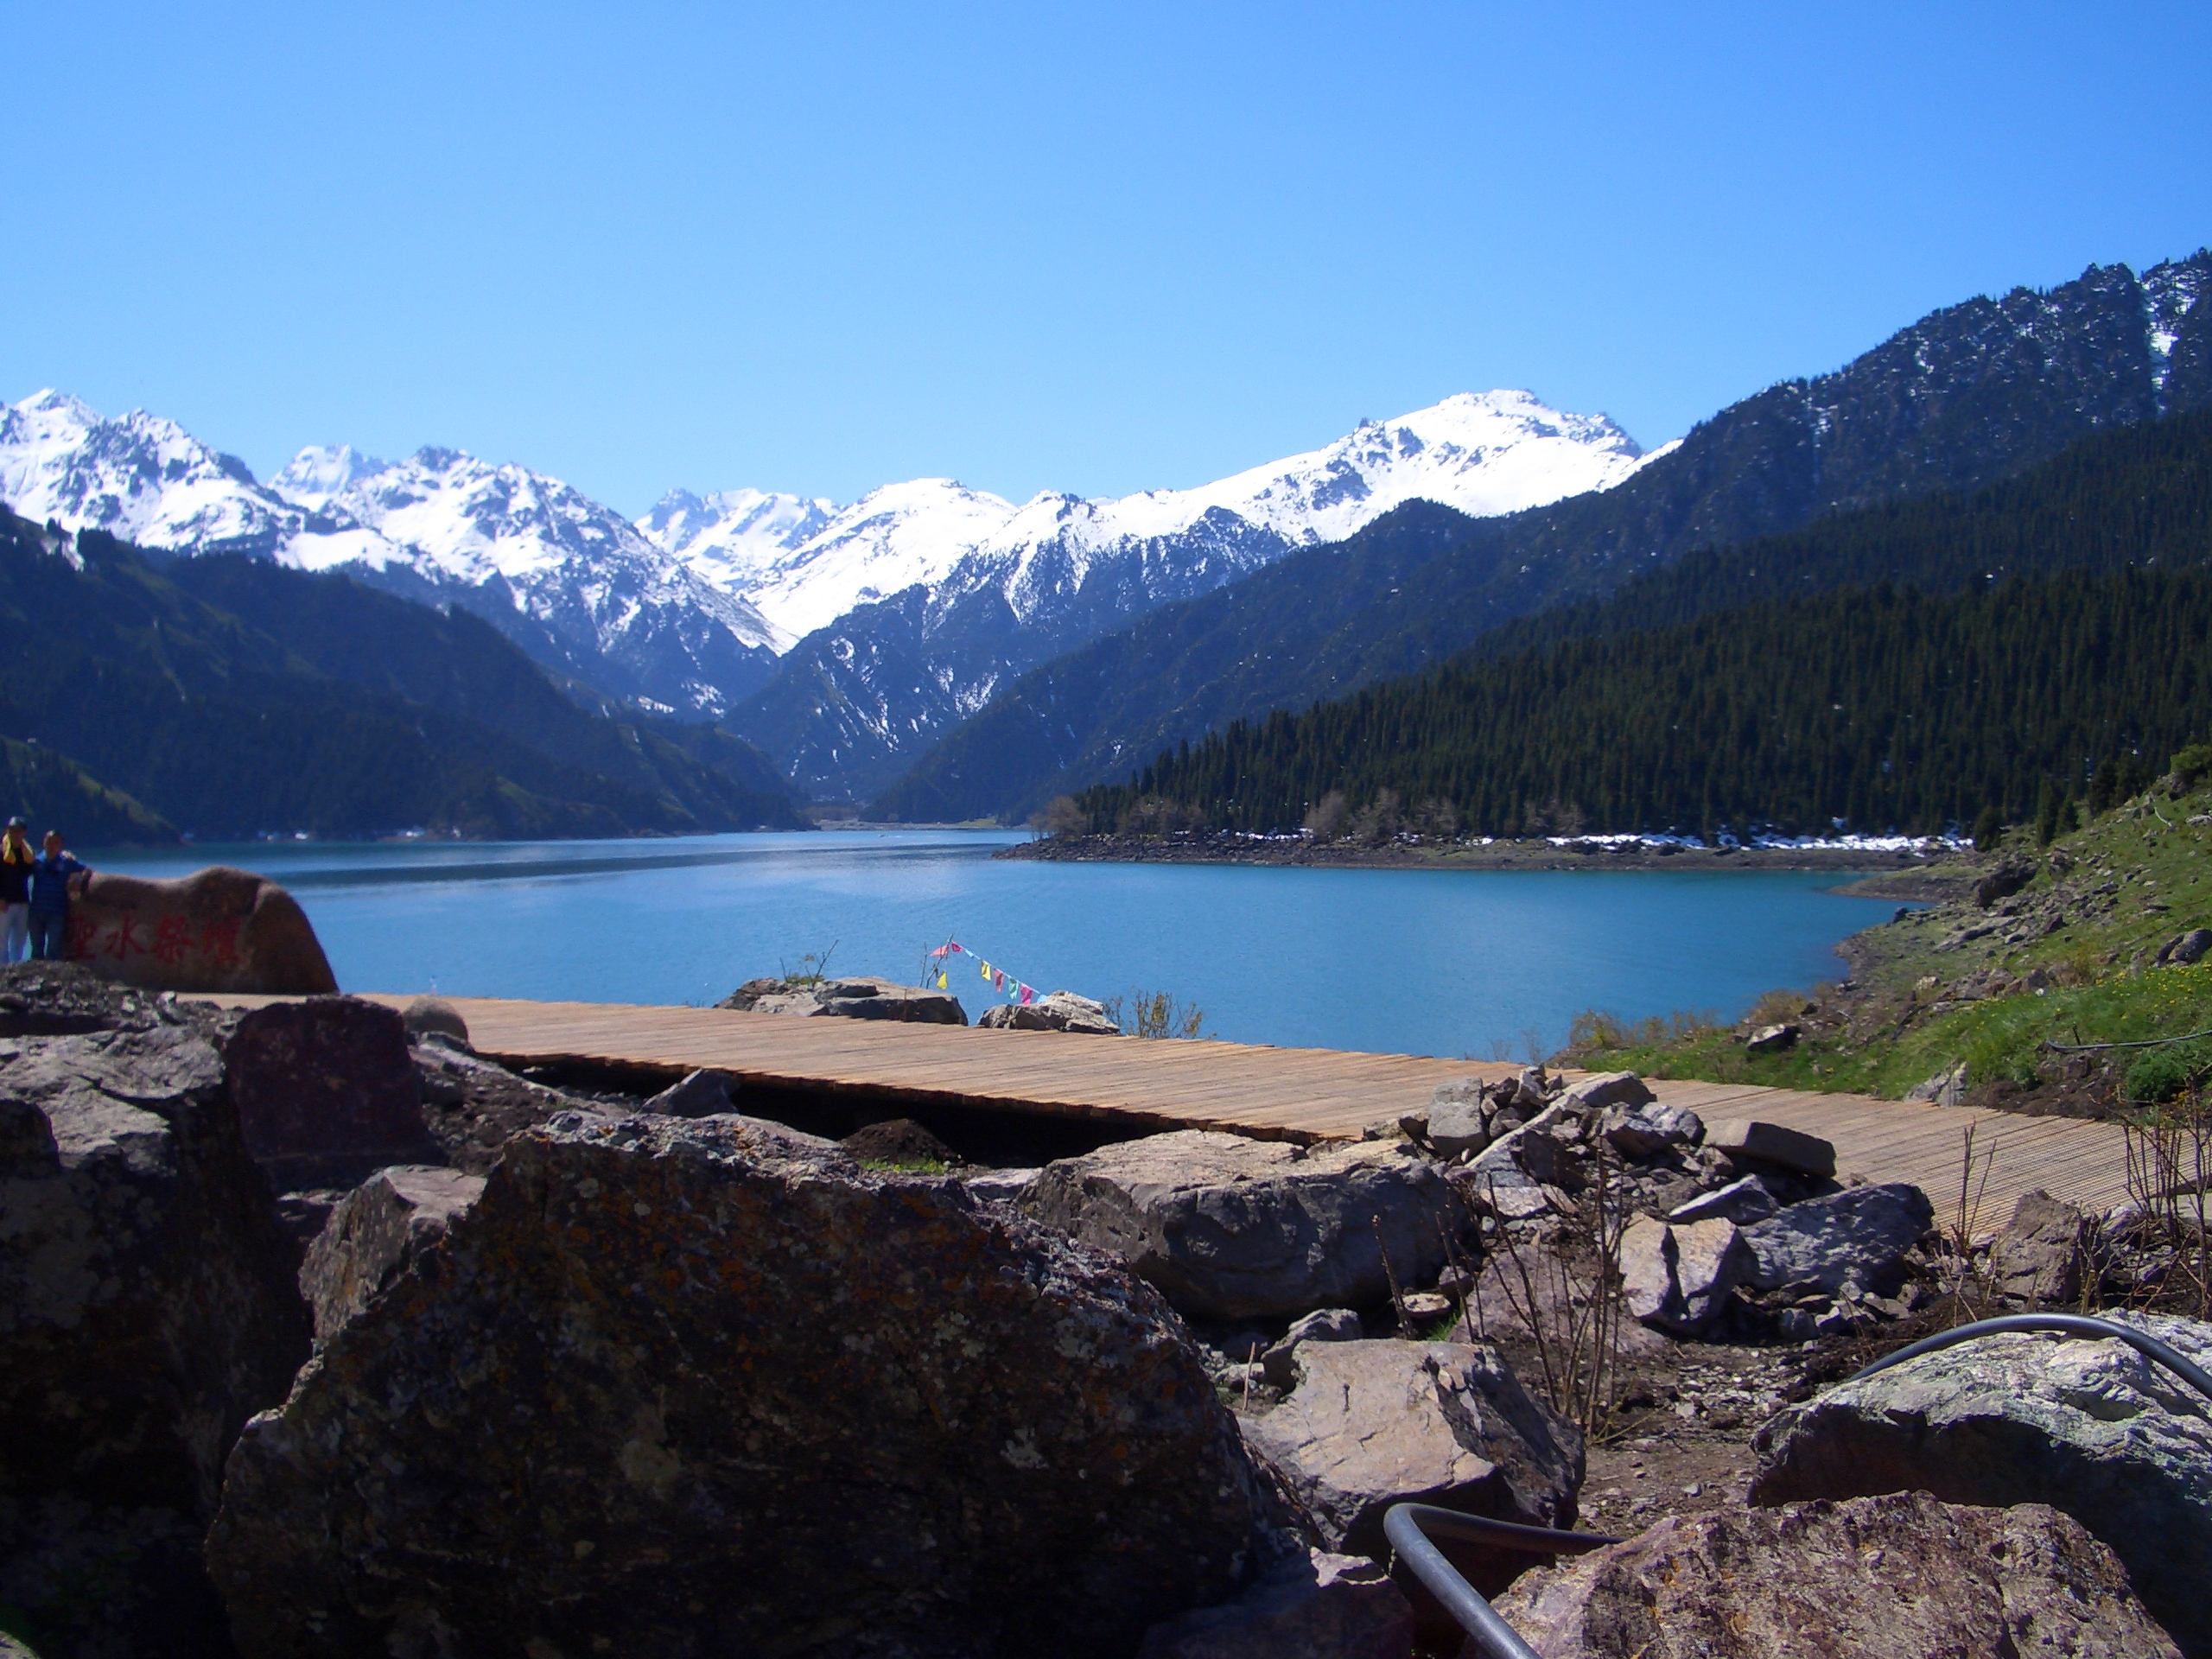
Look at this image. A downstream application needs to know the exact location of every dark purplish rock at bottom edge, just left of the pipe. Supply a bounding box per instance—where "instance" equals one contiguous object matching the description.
[1132,1548,1414,1659]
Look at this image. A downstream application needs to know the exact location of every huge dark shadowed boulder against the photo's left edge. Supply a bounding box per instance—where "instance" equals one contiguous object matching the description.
[0,1024,308,1655]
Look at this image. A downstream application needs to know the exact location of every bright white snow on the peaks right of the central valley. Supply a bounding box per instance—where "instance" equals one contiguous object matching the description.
[639,391,1642,637]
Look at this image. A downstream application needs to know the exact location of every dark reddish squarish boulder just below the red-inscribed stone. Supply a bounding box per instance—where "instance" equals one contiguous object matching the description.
[224,998,445,1192]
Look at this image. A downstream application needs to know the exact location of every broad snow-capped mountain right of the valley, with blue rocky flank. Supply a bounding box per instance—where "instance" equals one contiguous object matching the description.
[668,391,1646,794]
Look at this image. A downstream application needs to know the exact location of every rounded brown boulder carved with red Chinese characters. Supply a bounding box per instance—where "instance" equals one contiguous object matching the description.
[68,865,339,995]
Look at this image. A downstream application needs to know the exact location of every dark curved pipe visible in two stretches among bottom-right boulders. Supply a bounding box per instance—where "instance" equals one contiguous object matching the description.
[1382,1314,2212,1659]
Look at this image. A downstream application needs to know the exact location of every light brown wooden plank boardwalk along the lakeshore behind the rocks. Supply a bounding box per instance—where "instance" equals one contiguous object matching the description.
[285,998,2128,1230]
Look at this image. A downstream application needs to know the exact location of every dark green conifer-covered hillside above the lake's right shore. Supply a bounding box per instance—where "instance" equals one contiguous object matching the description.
[1079,411,2212,834]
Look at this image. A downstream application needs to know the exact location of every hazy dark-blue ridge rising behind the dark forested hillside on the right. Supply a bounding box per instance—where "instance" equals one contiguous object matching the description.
[876,252,2212,818]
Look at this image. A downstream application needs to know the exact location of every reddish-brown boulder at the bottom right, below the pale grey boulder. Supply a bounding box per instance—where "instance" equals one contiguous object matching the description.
[1497,1493,2179,1659]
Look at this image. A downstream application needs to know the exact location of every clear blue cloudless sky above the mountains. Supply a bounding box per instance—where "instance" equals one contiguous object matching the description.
[0,0,2212,513]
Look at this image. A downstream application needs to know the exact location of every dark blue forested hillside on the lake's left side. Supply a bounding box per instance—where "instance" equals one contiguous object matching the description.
[0,515,797,838]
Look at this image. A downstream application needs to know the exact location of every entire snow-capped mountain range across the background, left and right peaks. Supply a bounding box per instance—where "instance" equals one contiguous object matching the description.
[0,391,1642,794]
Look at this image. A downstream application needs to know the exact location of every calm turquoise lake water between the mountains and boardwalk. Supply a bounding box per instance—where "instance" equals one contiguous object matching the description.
[86,832,1891,1059]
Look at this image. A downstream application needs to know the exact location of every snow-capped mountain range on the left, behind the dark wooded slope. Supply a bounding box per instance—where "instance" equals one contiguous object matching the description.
[0,402,791,715]
